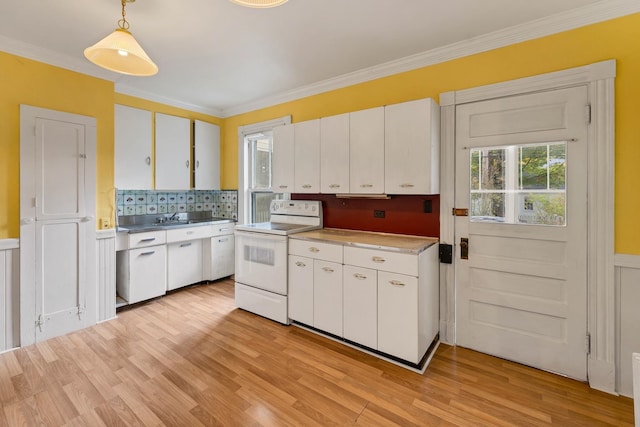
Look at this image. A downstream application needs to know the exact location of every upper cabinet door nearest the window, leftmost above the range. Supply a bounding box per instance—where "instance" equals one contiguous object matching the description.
[271,125,295,193]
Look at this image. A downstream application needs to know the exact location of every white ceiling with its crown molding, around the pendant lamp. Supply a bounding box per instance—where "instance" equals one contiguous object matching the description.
[0,0,637,117]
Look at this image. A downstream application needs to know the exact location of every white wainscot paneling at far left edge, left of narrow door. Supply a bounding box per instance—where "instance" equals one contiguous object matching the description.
[0,239,20,353]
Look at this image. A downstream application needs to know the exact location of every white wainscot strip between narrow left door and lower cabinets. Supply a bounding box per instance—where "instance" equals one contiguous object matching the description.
[96,229,116,322]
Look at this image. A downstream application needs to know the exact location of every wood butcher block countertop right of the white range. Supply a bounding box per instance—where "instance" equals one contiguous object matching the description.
[289,228,438,254]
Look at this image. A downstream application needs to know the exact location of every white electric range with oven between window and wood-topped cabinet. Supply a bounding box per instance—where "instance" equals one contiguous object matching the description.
[235,200,322,324]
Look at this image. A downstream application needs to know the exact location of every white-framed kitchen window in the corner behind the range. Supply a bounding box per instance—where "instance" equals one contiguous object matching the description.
[238,116,291,223]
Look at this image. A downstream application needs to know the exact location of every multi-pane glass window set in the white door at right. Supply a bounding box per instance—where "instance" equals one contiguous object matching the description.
[469,142,567,226]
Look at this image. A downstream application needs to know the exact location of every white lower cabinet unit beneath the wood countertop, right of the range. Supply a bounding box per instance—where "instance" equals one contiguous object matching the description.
[289,233,439,366]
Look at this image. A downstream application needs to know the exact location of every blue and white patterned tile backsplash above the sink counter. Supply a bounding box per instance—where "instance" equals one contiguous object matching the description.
[116,190,238,220]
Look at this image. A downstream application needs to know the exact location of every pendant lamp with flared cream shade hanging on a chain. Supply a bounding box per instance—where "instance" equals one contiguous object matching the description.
[84,0,158,76]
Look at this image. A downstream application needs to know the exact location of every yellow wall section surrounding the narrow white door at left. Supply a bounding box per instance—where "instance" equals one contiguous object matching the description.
[0,52,115,238]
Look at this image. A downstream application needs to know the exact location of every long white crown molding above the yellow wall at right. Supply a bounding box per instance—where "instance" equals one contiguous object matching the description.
[221,0,640,118]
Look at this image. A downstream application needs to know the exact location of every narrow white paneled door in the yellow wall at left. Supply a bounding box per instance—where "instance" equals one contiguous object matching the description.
[20,106,96,345]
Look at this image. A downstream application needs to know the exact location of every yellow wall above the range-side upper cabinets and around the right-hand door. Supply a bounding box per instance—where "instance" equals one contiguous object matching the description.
[223,14,640,254]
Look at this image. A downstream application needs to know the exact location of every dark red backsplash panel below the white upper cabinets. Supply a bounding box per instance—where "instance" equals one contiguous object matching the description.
[291,194,440,237]
